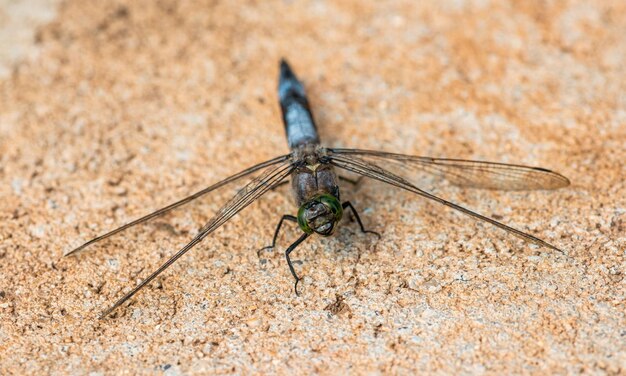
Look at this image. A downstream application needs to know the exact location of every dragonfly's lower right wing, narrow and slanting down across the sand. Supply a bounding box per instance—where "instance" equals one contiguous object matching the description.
[329,154,565,254]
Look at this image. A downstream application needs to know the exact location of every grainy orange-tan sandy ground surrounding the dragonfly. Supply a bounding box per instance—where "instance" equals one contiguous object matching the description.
[0,0,626,375]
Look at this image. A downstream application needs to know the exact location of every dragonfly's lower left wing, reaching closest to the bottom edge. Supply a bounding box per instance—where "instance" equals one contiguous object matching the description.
[100,161,294,318]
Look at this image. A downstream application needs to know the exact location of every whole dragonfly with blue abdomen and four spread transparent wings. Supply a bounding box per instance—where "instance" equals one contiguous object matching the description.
[66,59,570,318]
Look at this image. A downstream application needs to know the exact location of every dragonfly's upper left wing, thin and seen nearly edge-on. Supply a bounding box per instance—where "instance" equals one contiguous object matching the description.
[65,154,290,256]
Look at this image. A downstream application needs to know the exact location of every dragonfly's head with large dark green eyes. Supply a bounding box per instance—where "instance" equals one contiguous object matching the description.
[298,194,343,236]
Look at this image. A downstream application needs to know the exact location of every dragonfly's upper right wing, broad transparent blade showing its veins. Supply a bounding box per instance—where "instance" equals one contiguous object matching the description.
[329,149,570,191]
